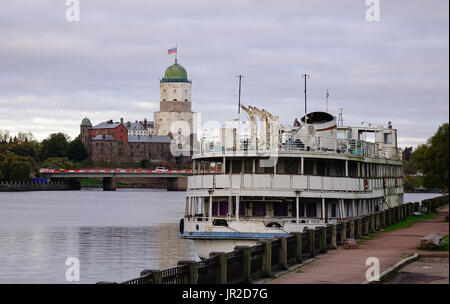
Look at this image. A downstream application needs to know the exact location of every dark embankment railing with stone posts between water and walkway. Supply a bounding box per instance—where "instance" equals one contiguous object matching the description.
[111,195,448,284]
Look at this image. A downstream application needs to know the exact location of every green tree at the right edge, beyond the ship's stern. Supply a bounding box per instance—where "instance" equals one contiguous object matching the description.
[411,123,449,191]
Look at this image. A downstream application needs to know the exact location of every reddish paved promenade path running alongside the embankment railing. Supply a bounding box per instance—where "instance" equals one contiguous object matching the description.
[267,205,449,284]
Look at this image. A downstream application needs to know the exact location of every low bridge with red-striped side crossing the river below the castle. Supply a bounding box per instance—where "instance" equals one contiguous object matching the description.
[40,169,197,191]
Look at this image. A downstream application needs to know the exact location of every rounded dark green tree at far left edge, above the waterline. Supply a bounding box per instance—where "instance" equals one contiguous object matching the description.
[0,153,32,181]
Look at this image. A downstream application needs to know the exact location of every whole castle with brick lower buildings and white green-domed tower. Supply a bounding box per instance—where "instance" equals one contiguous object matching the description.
[80,59,196,167]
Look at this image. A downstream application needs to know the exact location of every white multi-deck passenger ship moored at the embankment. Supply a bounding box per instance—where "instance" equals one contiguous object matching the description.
[180,106,403,257]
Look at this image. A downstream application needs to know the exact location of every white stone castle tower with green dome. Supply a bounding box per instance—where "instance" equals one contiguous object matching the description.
[154,59,194,137]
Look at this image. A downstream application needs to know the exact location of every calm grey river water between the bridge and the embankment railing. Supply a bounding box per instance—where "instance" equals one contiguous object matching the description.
[0,189,439,283]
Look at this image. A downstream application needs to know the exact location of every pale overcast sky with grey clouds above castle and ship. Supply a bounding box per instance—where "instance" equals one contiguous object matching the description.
[0,0,449,147]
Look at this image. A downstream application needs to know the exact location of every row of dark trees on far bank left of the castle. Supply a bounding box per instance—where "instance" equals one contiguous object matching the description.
[0,130,89,181]
